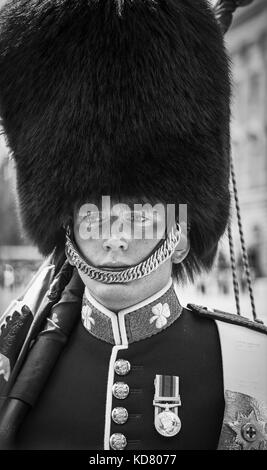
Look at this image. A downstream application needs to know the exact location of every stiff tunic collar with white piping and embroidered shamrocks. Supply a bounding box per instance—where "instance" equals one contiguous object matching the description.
[82,279,183,346]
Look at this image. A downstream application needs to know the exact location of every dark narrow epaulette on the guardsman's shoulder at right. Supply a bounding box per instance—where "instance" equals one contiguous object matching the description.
[187,304,267,334]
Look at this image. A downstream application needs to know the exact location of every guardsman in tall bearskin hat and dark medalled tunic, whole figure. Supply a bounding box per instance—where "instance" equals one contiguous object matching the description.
[0,0,267,450]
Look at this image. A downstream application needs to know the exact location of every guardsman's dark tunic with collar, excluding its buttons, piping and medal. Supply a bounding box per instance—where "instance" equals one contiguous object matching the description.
[16,280,224,450]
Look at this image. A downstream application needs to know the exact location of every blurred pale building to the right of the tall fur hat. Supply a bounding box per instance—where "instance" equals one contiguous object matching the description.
[226,0,267,277]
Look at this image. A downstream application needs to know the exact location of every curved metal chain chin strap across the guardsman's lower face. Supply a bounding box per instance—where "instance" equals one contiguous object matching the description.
[65,223,181,284]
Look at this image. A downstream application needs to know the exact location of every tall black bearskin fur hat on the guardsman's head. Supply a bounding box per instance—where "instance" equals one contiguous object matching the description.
[0,0,230,280]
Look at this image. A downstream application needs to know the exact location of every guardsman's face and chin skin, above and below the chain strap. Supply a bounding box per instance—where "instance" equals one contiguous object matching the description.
[74,202,175,310]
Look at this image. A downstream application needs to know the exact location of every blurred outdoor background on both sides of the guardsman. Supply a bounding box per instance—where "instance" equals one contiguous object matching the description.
[0,0,267,323]
